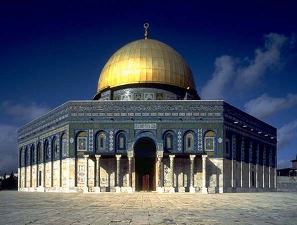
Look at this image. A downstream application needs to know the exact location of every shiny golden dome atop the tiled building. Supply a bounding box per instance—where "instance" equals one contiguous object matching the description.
[97,39,195,92]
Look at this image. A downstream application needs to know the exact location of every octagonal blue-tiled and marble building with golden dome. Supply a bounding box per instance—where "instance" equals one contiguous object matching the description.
[18,31,277,193]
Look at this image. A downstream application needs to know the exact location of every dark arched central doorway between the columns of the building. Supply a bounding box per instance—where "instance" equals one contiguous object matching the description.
[134,138,156,191]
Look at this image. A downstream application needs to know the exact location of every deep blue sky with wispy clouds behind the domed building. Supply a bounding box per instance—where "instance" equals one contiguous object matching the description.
[0,0,297,170]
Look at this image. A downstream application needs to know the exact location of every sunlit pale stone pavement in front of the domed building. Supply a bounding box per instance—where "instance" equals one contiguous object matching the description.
[0,191,297,225]
